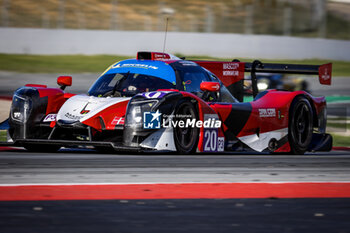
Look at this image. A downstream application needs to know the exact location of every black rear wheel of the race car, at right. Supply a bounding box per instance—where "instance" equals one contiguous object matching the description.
[288,97,313,154]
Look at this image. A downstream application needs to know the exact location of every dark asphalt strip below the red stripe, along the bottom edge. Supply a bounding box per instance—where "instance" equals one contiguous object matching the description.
[0,199,350,233]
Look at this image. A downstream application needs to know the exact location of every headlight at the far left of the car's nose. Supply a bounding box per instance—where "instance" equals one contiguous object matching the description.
[11,95,32,123]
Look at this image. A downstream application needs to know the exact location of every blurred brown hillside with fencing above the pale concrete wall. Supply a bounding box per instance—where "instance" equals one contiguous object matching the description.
[0,0,350,39]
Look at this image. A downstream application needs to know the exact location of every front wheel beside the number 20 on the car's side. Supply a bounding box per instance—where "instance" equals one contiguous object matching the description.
[174,101,199,154]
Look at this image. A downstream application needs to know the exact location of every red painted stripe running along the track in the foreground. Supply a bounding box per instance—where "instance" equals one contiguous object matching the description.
[0,182,350,201]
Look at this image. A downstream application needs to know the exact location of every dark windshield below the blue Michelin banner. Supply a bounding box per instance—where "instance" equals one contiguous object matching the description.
[88,72,176,97]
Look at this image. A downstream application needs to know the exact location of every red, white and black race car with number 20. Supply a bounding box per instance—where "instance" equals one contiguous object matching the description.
[0,52,332,154]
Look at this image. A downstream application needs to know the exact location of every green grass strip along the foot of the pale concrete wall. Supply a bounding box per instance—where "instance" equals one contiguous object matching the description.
[0,54,350,77]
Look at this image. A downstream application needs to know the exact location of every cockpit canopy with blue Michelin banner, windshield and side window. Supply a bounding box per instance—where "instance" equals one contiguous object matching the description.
[88,59,235,102]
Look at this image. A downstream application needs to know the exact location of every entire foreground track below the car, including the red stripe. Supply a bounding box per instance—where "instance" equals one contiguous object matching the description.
[0,150,350,233]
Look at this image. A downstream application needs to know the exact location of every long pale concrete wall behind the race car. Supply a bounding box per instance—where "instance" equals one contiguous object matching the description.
[0,28,350,61]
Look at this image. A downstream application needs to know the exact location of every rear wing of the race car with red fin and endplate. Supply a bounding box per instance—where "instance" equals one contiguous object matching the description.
[194,60,332,101]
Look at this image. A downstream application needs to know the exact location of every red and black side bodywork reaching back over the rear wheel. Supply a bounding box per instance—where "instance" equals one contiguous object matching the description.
[210,90,326,152]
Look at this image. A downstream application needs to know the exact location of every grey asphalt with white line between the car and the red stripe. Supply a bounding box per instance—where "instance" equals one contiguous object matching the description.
[0,149,350,184]
